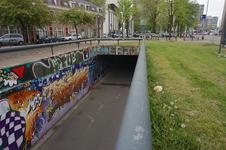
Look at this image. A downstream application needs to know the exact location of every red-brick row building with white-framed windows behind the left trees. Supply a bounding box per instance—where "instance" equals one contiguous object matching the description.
[0,0,103,43]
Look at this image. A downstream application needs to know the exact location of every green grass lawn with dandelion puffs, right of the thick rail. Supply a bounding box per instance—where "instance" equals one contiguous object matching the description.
[118,41,226,150]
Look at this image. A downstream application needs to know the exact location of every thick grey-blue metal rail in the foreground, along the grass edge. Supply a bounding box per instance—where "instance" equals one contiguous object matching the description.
[115,39,152,150]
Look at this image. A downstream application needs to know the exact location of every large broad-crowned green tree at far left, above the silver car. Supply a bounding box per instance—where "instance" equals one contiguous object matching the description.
[0,0,53,43]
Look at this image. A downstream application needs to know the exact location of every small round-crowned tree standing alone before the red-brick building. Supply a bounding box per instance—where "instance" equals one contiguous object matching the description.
[57,6,95,39]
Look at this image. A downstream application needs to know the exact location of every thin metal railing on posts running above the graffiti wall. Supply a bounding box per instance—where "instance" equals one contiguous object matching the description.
[0,38,143,55]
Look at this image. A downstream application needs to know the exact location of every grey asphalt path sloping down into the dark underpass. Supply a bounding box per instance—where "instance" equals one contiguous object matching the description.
[32,56,137,150]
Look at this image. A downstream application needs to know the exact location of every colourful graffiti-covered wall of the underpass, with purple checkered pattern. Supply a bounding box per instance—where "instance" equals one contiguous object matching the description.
[0,46,139,150]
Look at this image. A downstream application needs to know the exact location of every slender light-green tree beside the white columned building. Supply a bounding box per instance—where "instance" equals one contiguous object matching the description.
[116,0,136,37]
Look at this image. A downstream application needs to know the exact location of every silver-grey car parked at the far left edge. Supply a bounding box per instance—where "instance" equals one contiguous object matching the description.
[0,34,24,46]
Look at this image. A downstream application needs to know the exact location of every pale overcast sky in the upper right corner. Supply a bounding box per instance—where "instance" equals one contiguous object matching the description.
[196,0,226,25]
